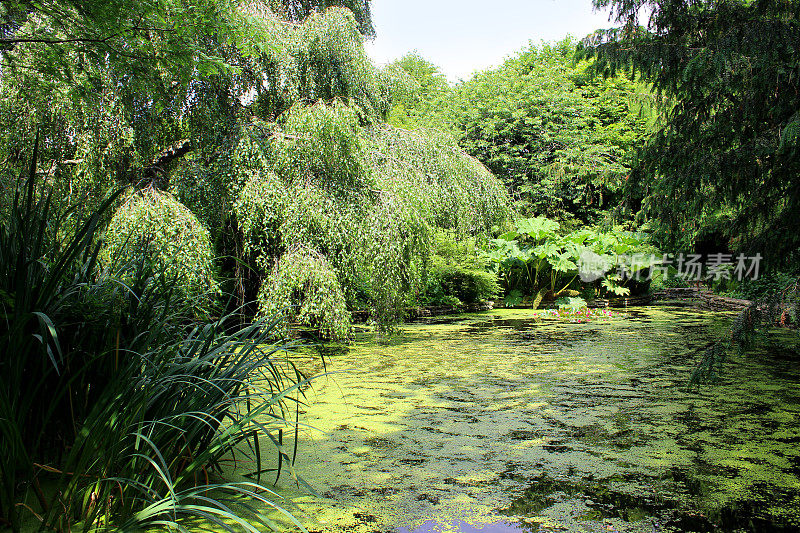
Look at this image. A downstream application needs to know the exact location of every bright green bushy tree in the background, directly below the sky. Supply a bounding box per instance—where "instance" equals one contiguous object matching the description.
[404,39,650,224]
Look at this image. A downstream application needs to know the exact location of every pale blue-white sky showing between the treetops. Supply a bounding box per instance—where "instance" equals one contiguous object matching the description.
[367,0,612,81]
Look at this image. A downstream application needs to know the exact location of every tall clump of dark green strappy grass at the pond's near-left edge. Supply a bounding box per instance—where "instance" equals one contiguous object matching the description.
[0,142,307,531]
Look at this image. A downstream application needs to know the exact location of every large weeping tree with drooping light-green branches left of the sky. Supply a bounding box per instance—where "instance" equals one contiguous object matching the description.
[0,0,508,337]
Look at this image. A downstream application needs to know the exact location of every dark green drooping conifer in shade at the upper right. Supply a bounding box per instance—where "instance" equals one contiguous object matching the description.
[585,0,800,268]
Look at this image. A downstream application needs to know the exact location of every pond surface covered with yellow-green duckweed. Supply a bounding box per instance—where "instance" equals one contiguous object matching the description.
[264,308,800,533]
